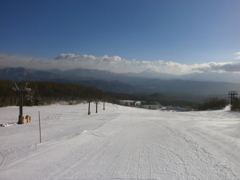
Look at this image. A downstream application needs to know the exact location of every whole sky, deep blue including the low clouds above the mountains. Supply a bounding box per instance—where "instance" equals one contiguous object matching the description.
[0,0,240,74]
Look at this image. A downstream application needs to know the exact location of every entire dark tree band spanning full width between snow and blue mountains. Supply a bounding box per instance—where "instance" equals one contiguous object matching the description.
[0,80,236,110]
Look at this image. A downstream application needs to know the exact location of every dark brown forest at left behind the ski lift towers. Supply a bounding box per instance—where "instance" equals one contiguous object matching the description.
[0,80,113,107]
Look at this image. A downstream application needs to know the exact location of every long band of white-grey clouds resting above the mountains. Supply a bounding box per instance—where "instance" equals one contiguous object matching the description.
[0,52,240,75]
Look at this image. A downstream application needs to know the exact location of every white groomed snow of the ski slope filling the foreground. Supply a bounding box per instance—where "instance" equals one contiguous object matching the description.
[0,103,240,180]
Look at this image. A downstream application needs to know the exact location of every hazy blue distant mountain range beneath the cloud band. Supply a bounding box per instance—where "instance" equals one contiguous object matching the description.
[0,67,240,95]
